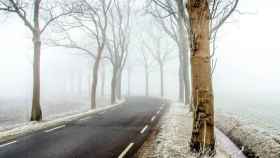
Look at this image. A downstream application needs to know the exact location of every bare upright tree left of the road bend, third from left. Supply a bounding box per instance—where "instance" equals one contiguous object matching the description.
[107,0,132,103]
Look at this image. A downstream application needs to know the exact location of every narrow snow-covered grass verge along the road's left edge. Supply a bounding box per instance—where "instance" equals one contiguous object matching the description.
[0,99,125,142]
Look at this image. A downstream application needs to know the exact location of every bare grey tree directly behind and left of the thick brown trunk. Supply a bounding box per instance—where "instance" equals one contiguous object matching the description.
[147,0,190,105]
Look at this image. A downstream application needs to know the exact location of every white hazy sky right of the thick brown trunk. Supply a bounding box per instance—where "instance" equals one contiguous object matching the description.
[214,0,280,107]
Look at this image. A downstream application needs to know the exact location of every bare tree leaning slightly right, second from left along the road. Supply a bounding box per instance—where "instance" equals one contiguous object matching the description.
[52,0,112,109]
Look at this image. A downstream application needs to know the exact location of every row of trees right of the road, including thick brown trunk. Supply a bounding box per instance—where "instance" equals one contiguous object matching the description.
[147,0,239,154]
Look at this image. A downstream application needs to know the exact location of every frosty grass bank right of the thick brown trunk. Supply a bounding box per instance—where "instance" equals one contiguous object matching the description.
[216,113,280,158]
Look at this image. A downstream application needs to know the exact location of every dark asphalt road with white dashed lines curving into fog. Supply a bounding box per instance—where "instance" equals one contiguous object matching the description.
[0,97,168,158]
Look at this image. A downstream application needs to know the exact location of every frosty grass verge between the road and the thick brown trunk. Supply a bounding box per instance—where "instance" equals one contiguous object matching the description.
[136,103,229,158]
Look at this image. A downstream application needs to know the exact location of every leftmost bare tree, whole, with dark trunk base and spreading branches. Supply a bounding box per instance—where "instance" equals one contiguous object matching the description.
[0,0,72,121]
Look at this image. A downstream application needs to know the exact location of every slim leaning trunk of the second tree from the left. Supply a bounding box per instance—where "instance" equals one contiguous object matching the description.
[91,48,103,109]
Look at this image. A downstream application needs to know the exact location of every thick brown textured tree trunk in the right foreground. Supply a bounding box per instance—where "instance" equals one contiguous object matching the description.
[187,0,215,153]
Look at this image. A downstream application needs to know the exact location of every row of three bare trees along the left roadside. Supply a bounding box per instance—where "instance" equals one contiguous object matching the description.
[0,0,132,121]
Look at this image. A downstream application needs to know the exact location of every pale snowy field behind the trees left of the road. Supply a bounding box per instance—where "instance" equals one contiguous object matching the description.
[0,97,110,131]
